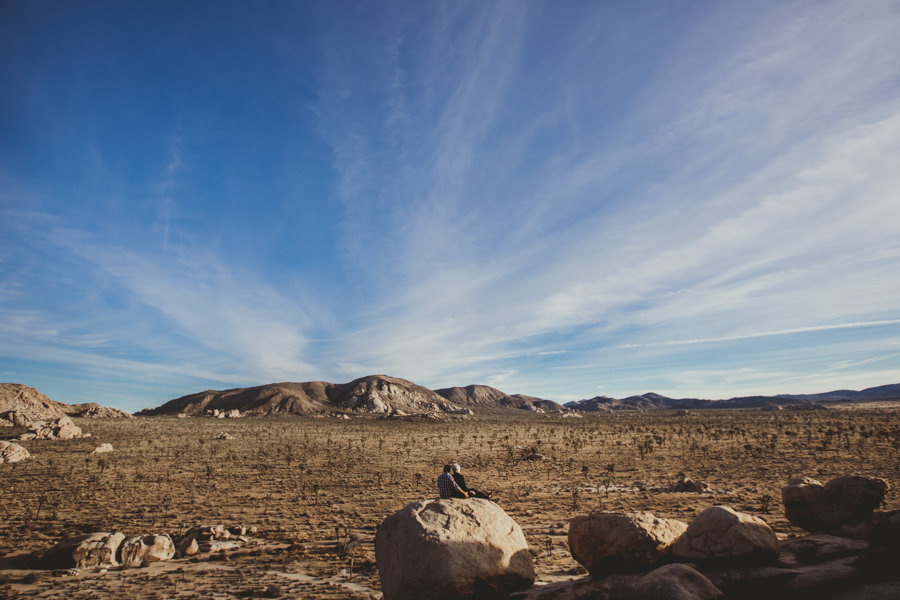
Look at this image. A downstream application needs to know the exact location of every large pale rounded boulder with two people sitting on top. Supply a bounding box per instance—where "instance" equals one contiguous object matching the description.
[375,498,535,600]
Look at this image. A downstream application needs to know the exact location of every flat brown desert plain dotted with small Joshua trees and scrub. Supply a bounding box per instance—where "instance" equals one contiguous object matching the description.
[0,405,900,599]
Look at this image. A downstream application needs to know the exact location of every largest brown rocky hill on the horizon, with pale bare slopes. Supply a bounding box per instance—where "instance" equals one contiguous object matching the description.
[137,375,472,416]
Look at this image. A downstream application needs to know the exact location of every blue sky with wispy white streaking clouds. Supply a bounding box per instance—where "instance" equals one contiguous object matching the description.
[0,0,900,410]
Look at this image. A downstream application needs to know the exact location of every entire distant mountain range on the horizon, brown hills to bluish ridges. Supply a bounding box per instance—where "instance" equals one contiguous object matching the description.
[136,375,900,417]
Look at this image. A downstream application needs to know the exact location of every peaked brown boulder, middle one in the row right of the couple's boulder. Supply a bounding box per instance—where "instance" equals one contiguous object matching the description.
[672,506,779,565]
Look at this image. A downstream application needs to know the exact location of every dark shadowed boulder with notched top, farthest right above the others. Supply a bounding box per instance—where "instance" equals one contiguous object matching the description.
[781,475,888,532]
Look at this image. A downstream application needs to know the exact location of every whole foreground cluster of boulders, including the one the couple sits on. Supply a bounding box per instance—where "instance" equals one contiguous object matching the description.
[375,477,900,600]
